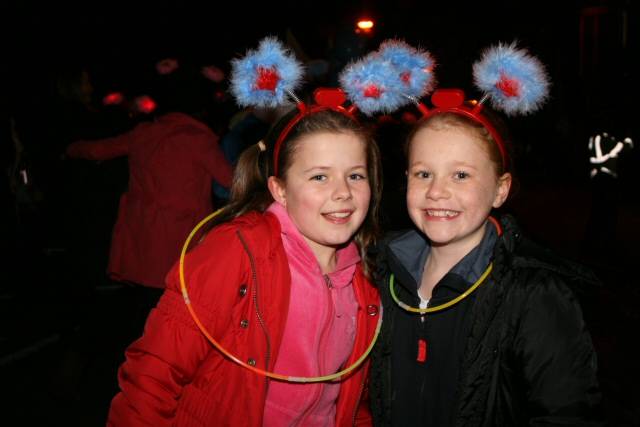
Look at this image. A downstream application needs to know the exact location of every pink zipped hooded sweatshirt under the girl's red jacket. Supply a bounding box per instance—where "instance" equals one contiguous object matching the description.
[263,203,360,427]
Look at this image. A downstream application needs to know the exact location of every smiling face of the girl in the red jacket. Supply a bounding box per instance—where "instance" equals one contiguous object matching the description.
[269,132,371,262]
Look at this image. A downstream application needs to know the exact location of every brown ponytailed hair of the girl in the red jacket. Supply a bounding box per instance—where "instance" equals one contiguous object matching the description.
[213,109,382,276]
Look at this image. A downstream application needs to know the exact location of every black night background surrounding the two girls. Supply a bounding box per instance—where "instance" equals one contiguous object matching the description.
[0,0,640,426]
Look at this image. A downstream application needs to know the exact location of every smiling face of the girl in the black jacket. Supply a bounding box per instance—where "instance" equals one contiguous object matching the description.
[407,126,511,253]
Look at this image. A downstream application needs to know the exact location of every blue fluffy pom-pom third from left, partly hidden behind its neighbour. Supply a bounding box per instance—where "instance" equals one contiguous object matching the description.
[378,40,435,98]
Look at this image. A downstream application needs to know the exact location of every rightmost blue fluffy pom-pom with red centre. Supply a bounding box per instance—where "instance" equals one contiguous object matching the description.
[473,43,549,115]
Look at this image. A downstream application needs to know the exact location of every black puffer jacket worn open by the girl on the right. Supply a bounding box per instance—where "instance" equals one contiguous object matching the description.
[369,217,601,427]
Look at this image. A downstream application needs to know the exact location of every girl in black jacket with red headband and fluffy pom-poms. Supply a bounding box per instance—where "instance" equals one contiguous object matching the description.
[370,42,600,427]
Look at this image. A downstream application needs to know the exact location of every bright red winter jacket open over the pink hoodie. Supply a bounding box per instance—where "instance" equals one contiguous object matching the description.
[108,212,380,427]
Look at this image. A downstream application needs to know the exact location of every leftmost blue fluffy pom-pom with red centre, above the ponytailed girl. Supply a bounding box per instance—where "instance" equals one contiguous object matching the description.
[231,37,302,108]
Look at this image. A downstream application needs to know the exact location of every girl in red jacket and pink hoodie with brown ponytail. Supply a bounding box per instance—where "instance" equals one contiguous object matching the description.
[108,38,381,426]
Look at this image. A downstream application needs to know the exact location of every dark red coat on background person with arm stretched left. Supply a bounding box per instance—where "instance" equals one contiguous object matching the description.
[67,113,232,288]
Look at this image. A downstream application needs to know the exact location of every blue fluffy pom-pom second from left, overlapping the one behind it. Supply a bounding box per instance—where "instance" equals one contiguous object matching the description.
[340,53,410,115]
